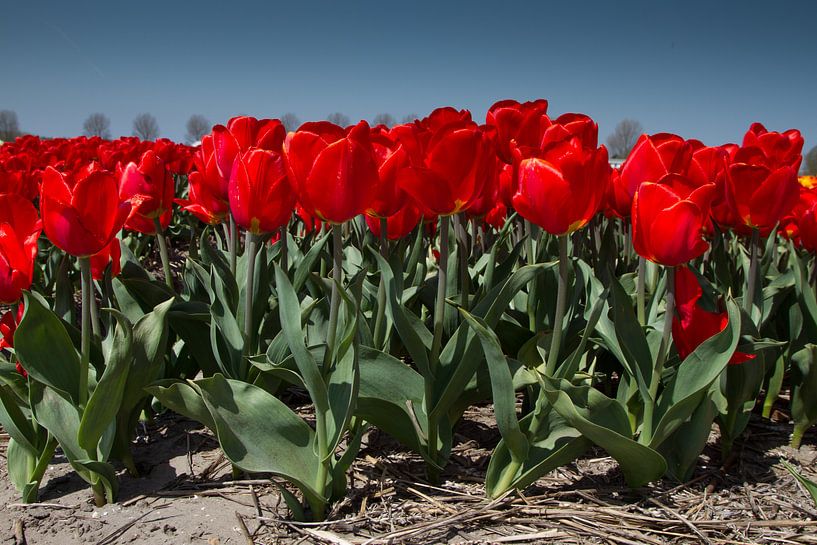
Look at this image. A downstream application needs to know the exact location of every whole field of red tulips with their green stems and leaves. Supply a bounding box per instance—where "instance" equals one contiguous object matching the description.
[0,100,817,536]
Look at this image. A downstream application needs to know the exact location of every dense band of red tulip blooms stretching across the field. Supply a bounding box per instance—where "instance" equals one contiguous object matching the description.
[0,100,817,303]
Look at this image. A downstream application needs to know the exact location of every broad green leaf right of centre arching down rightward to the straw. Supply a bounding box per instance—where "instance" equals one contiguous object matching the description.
[540,377,667,488]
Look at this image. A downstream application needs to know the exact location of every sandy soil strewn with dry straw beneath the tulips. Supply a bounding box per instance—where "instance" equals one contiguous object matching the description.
[0,406,817,545]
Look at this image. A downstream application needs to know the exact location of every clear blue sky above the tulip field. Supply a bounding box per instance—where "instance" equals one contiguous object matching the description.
[0,0,817,149]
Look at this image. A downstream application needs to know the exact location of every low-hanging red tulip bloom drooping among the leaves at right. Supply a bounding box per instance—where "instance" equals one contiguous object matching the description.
[672,267,755,365]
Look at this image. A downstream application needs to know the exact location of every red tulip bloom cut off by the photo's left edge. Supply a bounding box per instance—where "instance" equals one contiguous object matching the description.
[0,193,42,304]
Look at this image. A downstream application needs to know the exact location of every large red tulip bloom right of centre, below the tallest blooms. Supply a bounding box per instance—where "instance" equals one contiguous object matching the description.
[512,116,610,235]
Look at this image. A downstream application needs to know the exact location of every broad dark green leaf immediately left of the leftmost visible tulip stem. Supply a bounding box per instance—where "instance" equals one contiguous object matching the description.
[14,293,85,401]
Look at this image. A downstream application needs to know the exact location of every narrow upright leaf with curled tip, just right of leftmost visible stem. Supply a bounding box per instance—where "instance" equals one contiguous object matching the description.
[77,309,133,452]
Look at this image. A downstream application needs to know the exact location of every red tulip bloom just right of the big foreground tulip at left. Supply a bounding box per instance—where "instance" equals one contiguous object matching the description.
[119,150,176,235]
